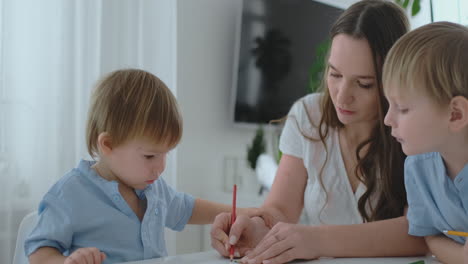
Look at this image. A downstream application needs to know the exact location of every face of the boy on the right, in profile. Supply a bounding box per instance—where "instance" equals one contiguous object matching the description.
[384,87,450,155]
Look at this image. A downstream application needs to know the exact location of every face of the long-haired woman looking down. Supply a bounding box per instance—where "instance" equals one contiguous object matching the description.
[327,34,378,125]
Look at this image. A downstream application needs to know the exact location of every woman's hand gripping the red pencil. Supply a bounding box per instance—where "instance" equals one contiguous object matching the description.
[211,213,270,257]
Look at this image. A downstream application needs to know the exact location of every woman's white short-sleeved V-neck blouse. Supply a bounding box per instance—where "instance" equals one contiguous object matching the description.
[279,93,372,225]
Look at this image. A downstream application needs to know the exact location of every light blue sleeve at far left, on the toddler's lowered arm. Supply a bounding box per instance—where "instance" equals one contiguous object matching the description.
[24,194,73,256]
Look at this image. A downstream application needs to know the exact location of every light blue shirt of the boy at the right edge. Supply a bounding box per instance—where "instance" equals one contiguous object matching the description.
[405,152,468,244]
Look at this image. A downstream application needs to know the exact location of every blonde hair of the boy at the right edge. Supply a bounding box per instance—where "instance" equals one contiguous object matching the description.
[383,22,468,105]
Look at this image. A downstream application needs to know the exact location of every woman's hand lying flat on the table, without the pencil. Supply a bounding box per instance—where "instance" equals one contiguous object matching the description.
[241,222,319,264]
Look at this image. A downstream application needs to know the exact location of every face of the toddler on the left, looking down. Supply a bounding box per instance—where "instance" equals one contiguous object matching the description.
[107,139,170,189]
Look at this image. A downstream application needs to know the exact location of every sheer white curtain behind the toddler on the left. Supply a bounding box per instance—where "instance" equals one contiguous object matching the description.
[0,0,177,263]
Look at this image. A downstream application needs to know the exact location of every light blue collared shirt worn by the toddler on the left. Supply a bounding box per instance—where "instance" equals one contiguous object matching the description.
[24,160,195,263]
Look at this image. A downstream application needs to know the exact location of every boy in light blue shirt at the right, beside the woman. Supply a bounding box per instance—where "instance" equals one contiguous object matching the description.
[383,22,468,263]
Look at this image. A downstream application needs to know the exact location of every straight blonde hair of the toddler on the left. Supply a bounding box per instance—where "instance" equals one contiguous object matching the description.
[86,69,182,157]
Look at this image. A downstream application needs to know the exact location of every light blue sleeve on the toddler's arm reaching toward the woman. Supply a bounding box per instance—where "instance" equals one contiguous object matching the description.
[161,180,195,231]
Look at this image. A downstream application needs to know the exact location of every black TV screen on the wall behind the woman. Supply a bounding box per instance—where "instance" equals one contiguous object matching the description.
[233,0,343,124]
